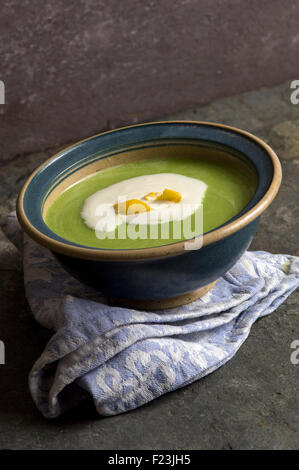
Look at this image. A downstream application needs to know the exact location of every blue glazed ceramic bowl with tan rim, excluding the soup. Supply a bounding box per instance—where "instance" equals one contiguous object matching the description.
[17,121,281,308]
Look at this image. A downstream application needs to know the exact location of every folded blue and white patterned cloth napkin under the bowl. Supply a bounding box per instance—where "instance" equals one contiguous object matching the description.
[2,213,299,418]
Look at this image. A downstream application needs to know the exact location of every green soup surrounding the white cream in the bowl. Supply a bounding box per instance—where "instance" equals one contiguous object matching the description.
[44,155,257,249]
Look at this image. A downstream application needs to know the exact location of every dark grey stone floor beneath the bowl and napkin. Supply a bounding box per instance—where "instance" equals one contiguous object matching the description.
[0,84,299,449]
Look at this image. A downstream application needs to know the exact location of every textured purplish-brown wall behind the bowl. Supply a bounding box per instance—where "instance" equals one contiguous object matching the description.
[0,0,299,160]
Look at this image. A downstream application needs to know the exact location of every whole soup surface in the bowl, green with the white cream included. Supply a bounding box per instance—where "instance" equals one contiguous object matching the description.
[45,157,257,249]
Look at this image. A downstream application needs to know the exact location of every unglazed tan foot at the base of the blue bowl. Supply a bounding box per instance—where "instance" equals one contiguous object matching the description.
[109,280,217,310]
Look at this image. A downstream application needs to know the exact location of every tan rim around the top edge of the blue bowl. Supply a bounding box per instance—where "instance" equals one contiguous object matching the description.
[16,120,282,261]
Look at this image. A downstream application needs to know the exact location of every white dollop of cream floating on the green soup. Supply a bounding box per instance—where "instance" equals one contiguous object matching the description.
[81,173,207,232]
